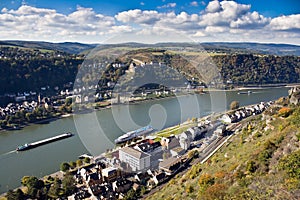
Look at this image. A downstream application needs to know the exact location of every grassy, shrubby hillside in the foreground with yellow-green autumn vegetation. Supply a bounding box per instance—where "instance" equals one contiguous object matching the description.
[147,98,300,200]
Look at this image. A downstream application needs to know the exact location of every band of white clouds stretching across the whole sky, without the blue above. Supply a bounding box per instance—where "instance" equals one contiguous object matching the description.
[0,0,300,44]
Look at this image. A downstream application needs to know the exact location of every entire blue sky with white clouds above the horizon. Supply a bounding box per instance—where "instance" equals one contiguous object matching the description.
[0,0,300,45]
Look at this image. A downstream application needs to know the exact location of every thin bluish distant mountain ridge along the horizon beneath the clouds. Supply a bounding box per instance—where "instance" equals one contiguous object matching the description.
[0,40,300,56]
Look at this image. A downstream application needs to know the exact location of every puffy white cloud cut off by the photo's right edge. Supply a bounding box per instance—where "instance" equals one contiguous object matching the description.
[270,14,300,30]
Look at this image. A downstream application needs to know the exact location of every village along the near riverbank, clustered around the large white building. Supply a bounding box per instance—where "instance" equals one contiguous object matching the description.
[63,101,273,199]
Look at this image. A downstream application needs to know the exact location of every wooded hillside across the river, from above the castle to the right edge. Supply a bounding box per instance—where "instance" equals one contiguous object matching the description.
[121,47,300,87]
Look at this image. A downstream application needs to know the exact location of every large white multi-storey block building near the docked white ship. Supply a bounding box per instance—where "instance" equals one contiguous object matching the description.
[119,147,151,171]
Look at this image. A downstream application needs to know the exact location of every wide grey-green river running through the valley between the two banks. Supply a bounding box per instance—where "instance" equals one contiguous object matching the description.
[0,87,289,194]
